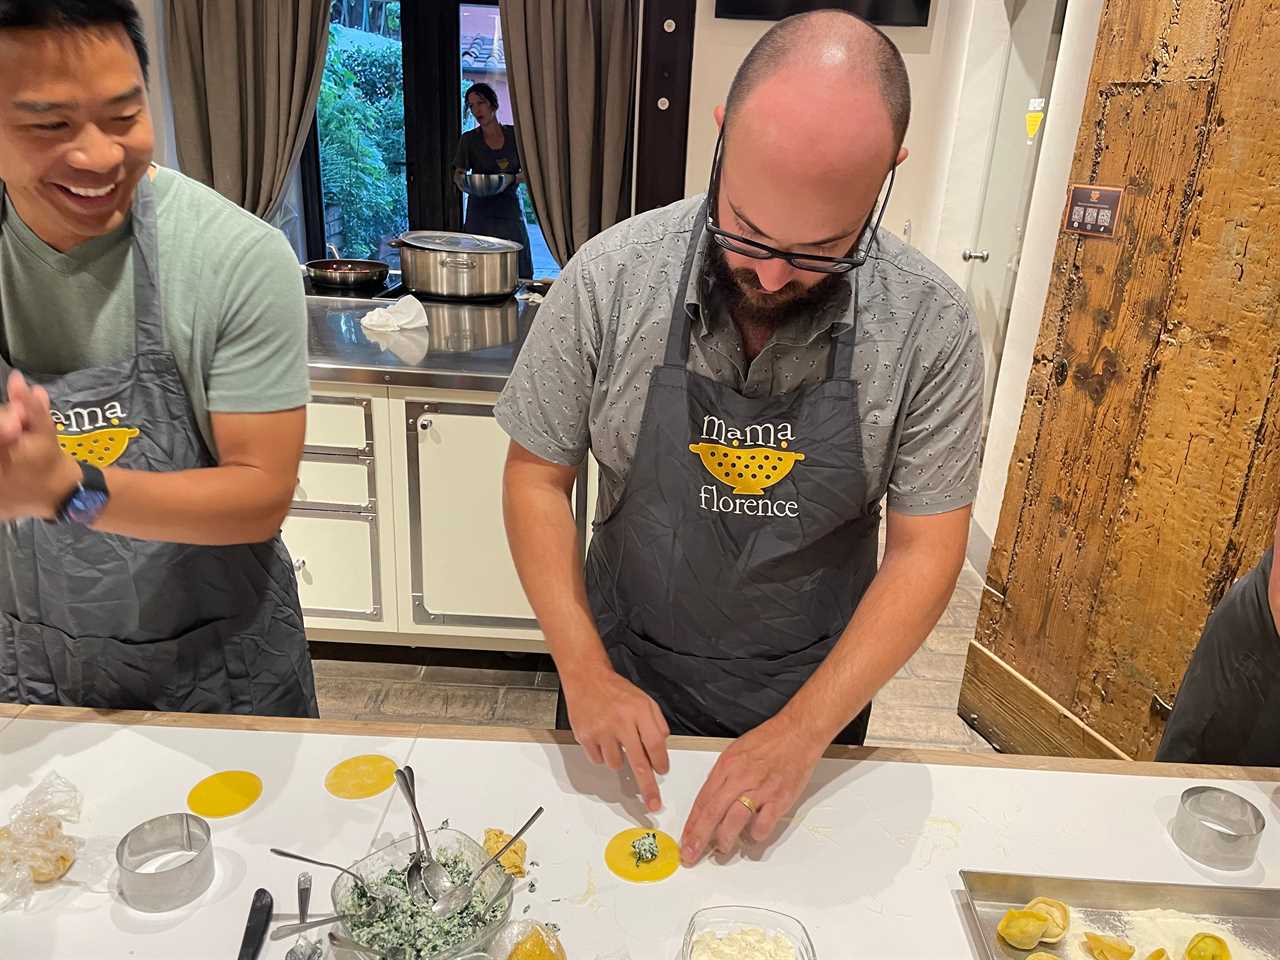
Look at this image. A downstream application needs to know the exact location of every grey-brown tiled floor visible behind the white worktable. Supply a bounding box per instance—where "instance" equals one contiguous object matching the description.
[312,564,991,753]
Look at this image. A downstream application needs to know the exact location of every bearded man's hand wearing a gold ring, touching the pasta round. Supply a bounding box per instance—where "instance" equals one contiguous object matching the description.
[680,713,827,867]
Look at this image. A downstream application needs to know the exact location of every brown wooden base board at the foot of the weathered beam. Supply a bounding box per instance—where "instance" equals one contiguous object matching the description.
[959,644,1129,760]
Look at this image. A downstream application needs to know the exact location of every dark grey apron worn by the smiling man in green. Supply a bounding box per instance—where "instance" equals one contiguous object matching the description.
[0,177,317,717]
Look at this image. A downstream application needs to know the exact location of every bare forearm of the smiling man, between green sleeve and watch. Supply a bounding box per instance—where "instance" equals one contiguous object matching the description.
[93,466,293,545]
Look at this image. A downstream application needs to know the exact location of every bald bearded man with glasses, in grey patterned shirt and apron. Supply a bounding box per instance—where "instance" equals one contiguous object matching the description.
[497,10,983,864]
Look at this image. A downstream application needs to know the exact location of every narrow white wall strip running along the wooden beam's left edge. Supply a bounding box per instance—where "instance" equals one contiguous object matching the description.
[969,0,1103,571]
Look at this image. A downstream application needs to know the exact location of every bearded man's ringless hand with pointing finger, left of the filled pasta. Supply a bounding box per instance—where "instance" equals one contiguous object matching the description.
[561,667,671,810]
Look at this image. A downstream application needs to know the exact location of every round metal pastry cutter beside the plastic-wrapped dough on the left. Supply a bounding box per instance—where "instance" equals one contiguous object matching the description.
[115,813,214,913]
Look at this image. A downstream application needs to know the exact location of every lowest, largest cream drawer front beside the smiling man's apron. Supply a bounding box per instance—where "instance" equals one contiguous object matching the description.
[282,509,383,621]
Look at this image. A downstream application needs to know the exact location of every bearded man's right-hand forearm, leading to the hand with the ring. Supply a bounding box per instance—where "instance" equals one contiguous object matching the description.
[782,527,964,748]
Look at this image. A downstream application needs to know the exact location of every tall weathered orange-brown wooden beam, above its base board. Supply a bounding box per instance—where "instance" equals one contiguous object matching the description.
[977,0,1280,758]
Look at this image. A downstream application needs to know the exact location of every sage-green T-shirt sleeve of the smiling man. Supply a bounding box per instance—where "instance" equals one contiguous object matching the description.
[206,230,311,413]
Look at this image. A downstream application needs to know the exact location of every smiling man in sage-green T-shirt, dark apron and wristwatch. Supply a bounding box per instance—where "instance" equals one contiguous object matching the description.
[0,0,316,716]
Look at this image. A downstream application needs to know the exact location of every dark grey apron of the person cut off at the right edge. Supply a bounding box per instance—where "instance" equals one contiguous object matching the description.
[1156,550,1280,767]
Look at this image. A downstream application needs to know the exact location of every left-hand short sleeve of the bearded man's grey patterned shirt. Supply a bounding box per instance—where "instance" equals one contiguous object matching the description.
[494,253,602,466]
